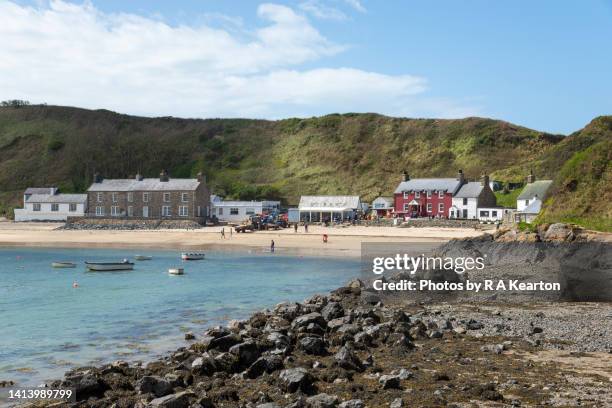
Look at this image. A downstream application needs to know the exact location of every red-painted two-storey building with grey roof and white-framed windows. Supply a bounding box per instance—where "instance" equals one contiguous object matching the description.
[394,170,466,218]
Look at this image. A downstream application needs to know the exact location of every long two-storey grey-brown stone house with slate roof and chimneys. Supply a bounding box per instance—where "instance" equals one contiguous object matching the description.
[87,171,211,222]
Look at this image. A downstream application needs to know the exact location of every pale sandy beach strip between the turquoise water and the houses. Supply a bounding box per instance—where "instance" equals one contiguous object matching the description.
[0,222,483,256]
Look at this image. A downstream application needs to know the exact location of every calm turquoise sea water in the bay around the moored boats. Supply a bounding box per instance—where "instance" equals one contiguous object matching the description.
[0,245,359,385]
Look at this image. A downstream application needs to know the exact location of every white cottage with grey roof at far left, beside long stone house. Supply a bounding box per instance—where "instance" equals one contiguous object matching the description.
[15,187,87,222]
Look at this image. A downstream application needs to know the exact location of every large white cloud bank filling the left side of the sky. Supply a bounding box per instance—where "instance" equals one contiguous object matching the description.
[0,0,477,118]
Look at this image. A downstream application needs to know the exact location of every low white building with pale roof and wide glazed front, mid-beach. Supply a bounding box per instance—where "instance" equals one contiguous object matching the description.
[298,196,362,222]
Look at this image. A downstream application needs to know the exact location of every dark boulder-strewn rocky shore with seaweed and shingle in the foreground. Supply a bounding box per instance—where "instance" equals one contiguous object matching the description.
[9,227,612,408]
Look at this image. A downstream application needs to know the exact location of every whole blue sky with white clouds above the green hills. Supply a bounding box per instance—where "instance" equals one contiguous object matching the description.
[0,0,612,134]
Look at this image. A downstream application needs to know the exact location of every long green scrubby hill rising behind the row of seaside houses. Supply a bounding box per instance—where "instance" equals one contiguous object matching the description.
[0,106,600,231]
